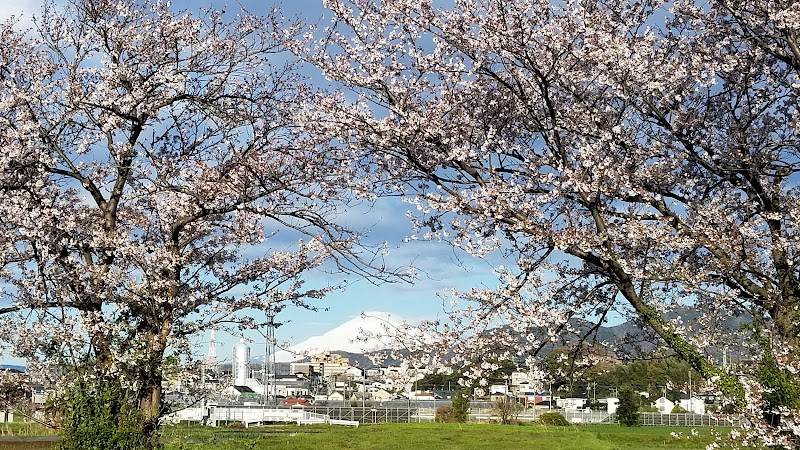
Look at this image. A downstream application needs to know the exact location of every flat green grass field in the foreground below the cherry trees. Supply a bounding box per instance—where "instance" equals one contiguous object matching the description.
[164,424,732,450]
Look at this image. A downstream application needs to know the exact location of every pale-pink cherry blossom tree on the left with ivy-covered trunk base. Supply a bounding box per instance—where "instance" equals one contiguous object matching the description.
[0,0,392,442]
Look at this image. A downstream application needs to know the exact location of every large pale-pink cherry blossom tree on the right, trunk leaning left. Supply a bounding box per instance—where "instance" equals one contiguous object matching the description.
[298,0,800,448]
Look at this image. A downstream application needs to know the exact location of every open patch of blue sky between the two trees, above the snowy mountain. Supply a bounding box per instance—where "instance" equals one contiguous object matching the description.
[245,193,496,356]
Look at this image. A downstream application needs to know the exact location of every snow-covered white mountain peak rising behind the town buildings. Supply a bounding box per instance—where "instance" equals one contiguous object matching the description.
[270,312,403,362]
